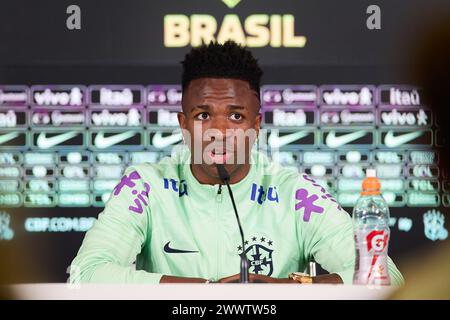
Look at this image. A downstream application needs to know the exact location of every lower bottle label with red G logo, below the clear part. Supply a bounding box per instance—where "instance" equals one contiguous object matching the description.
[354,230,390,285]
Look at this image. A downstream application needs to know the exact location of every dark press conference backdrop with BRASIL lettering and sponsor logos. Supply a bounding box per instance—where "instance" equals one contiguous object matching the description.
[0,0,450,282]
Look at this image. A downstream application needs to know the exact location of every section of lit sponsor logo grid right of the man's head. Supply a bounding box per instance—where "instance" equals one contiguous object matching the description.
[261,85,449,207]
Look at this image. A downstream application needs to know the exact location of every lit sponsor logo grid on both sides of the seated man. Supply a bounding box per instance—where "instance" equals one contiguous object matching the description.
[0,84,450,241]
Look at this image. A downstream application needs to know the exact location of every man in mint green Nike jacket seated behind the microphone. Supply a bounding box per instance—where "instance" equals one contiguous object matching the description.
[71,42,403,285]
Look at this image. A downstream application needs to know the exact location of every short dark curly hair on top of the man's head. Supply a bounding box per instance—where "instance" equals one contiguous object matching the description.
[181,41,263,98]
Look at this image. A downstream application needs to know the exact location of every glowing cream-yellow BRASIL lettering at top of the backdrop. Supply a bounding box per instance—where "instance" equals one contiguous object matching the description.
[164,0,306,48]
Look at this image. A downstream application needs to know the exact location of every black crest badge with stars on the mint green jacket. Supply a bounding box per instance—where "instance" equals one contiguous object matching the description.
[238,236,274,276]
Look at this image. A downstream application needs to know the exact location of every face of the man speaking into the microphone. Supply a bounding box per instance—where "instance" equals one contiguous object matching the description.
[178,78,261,183]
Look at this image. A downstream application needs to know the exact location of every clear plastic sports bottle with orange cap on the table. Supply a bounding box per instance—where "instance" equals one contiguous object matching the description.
[353,169,391,285]
